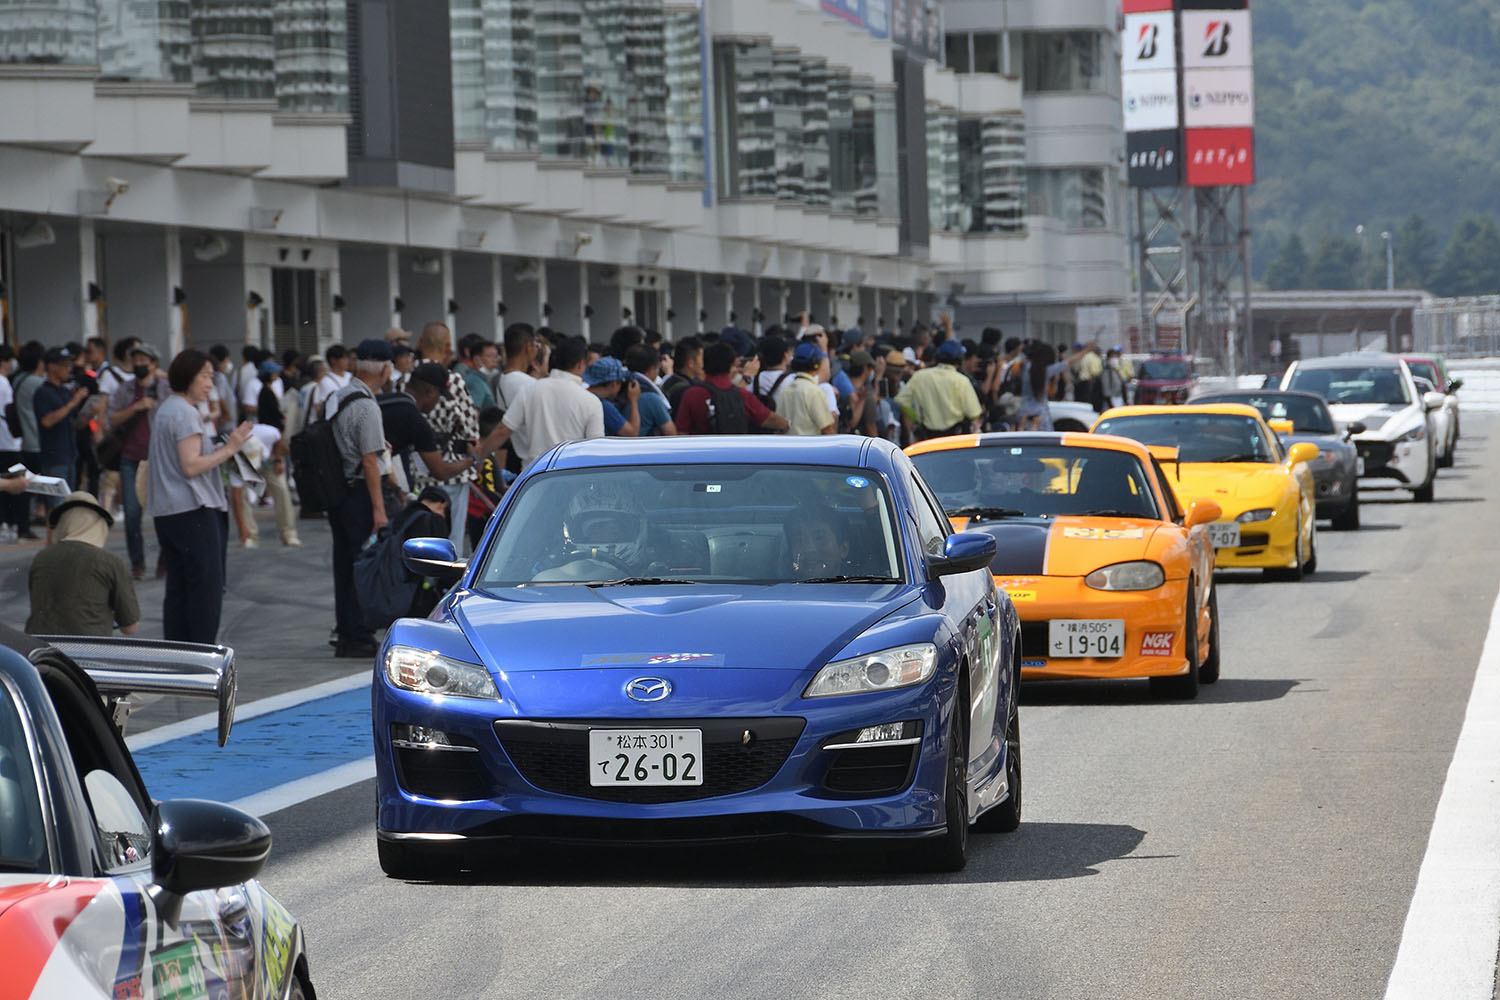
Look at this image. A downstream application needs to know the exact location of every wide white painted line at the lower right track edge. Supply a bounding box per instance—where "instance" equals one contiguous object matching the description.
[1386,590,1500,1000]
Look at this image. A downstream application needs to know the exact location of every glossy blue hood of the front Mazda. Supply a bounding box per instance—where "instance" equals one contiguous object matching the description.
[447,583,918,675]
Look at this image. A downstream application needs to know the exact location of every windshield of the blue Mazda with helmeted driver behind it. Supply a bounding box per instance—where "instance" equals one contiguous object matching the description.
[474,465,902,589]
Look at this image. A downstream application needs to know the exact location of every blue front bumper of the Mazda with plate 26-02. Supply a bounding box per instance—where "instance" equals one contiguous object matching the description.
[374,673,954,841]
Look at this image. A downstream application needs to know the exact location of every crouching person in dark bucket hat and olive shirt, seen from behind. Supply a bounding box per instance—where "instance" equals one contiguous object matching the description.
[26,490,141,636]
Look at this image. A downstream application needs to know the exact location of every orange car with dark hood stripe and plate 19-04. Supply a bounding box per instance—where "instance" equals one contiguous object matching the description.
[908,433,1221,697]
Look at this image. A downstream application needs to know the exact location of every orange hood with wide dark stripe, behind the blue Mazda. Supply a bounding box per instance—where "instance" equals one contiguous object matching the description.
[954,517,1161,577]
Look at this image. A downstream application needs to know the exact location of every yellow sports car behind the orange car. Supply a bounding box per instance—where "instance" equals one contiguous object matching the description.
[1094,403,1319,580]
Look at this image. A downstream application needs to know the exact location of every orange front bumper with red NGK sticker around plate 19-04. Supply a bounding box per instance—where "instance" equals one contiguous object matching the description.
[1004,577,1188,681]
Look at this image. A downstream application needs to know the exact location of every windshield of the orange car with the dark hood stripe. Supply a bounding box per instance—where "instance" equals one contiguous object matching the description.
[912,445,1158,520]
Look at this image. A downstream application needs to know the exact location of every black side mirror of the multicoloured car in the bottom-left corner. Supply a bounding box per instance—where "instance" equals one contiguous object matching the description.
[150,799,272,925]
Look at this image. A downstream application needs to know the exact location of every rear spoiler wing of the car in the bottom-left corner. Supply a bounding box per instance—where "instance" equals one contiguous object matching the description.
[36,636,237,747]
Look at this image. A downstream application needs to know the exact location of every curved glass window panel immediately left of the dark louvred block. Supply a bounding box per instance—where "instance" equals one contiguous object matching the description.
[275,0,350,114]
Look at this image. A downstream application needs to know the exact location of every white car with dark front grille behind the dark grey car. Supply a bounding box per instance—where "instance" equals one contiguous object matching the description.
[1281,354,1443,504]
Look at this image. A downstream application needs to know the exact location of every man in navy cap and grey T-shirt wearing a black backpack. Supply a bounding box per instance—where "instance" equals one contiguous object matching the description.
[329,339,392,658]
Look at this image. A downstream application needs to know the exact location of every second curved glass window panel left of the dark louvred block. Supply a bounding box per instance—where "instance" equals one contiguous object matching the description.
[191,0,276,100]
